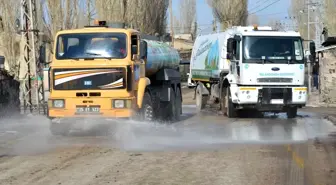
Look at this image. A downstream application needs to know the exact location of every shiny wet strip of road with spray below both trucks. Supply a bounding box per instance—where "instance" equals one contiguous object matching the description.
[0,105,336,151]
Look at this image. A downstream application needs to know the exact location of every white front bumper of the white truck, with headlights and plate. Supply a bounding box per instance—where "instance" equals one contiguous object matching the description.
[231,87,307,106]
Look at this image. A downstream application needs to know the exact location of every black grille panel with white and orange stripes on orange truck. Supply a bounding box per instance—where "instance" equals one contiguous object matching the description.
[52,68,126,90]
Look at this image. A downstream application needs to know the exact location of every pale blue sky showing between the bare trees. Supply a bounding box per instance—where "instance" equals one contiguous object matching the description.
[168,0,291,32]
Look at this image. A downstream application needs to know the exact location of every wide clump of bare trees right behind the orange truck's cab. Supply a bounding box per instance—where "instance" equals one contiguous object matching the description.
[95,0,169,35]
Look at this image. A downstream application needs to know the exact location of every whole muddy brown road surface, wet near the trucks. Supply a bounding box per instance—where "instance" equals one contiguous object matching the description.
[0,89,336,185]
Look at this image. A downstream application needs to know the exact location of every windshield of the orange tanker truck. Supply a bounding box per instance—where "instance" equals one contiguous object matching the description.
[56,33,127,60]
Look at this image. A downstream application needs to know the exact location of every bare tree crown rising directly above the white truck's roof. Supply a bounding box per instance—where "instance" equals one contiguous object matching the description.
[207,0,248,30]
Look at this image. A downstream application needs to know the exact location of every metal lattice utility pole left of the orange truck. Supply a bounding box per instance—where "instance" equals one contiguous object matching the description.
[20,0,45,114]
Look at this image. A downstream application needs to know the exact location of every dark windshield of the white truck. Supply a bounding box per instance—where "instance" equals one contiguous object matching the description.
[243,36,304,63]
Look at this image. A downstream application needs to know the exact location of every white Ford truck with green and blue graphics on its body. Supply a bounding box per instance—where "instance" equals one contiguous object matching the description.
[190,26,307,118]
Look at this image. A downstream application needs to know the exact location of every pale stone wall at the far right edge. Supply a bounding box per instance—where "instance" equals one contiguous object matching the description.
[320,49,336,104]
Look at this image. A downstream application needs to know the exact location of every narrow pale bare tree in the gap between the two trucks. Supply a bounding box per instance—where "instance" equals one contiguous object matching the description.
[180,0,196,33]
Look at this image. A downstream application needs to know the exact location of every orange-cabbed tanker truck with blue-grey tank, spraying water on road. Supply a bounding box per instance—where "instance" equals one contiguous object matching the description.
[43,21,182,135]
